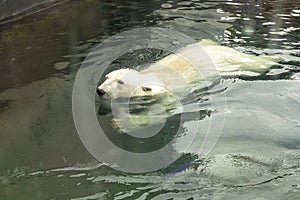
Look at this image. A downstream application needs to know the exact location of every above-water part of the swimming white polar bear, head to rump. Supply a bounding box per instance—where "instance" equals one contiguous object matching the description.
[97,40,281,99]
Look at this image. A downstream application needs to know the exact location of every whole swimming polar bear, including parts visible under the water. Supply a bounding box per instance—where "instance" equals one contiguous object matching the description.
[97,40,280,132]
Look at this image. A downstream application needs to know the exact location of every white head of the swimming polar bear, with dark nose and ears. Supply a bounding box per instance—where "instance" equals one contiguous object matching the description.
[97,69,167,99]
